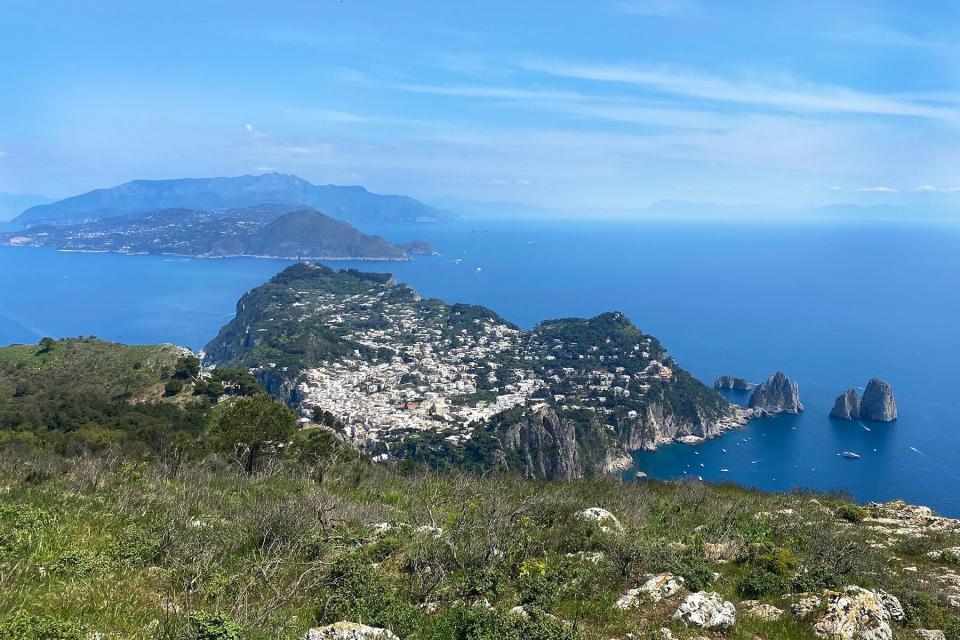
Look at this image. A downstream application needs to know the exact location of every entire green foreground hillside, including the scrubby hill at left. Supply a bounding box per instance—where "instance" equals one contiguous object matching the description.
[0,340,960,640]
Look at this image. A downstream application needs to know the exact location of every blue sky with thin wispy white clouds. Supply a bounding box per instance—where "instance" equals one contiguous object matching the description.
[0,0,960,210]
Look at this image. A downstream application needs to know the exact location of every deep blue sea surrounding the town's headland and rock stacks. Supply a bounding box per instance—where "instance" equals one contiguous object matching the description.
[0,221,960,516]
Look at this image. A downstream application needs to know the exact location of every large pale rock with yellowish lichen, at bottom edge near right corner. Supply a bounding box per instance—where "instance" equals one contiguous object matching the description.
[813,586,902,640]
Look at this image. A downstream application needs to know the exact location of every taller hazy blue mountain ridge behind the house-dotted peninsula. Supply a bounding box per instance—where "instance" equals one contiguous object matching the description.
[13,173,450,228]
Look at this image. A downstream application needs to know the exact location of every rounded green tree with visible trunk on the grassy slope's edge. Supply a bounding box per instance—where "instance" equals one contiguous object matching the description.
[215,395,297,476]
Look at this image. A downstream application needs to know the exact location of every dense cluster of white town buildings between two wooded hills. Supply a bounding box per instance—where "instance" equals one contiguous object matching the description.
[284,284,684,448]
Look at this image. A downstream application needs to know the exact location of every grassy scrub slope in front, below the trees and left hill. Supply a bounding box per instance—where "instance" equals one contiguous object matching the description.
[0,455,958,640]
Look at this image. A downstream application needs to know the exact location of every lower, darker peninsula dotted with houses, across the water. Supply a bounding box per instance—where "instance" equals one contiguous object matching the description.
[0,205,432,260]
